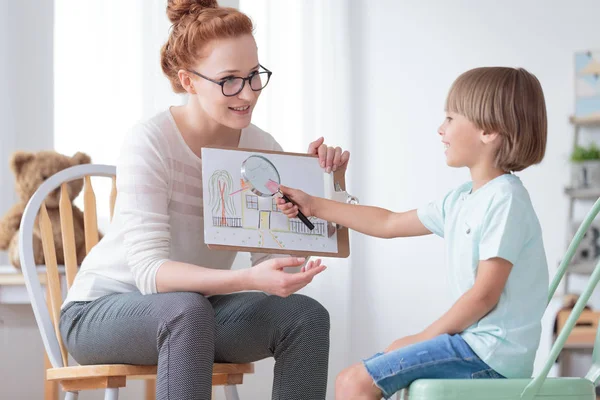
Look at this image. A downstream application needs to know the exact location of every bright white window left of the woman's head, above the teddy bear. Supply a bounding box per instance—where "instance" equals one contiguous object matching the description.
[54,0,184,230]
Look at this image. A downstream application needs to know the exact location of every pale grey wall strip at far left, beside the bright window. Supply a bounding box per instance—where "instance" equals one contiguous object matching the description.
[0,0,53,264]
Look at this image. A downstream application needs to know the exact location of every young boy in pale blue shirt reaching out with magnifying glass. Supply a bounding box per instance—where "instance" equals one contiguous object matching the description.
[278,67,548,400]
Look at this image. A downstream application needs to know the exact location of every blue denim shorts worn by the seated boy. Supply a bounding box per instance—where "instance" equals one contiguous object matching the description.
[363,334,504,399]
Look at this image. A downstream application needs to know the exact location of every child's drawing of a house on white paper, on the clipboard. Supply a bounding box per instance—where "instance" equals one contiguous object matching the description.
[202,149,337,252]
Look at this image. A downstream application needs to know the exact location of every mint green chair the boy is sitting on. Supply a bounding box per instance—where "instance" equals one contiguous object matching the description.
[401,199,600,400]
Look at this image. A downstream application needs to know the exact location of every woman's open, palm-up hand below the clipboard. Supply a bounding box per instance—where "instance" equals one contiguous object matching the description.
[248,257,327,297]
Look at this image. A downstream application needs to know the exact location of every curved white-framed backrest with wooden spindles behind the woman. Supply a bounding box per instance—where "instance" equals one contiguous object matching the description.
[19,164,117,368]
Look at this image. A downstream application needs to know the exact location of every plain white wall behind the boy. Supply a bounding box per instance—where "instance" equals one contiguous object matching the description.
[351,0,600,376]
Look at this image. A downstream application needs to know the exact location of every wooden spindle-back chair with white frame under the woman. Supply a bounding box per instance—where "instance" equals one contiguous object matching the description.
[19,164,254,400]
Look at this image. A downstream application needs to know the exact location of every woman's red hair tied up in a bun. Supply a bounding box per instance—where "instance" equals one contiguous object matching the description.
[160,0,254,93]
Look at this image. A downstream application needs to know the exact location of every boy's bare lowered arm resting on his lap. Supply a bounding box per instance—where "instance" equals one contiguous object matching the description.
[386,257,512,351]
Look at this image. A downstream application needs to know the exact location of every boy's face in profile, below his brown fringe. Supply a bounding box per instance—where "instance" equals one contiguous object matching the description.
[438,112,487,168]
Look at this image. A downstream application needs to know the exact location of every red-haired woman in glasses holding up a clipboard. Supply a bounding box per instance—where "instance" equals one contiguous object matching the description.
[60,0,349,400]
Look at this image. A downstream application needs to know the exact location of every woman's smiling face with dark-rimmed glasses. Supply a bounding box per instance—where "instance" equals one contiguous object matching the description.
[190,35,267,129]
